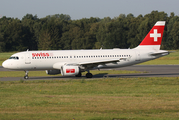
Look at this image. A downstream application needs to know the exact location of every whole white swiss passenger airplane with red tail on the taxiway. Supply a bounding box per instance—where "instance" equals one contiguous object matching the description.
[2,21,169,79]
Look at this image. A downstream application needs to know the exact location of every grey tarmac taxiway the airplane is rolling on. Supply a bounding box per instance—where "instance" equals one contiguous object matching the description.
[0,65,179,81]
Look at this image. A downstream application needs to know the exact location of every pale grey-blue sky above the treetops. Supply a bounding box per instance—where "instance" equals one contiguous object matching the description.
[0,0,179,20]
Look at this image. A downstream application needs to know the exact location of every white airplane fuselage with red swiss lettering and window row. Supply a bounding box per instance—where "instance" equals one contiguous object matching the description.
[3,49,166,71]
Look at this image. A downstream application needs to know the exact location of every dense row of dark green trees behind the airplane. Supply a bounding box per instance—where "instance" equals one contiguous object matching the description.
[0,11,179,52]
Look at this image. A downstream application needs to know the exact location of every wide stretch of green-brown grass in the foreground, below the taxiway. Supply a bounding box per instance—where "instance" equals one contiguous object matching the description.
[0,77,179,120]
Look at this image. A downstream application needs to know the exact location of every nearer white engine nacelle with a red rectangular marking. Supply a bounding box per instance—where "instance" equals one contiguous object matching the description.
[61,65,80,76]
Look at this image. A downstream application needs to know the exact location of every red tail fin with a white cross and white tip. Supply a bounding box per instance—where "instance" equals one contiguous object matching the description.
[138,21,165,48]
